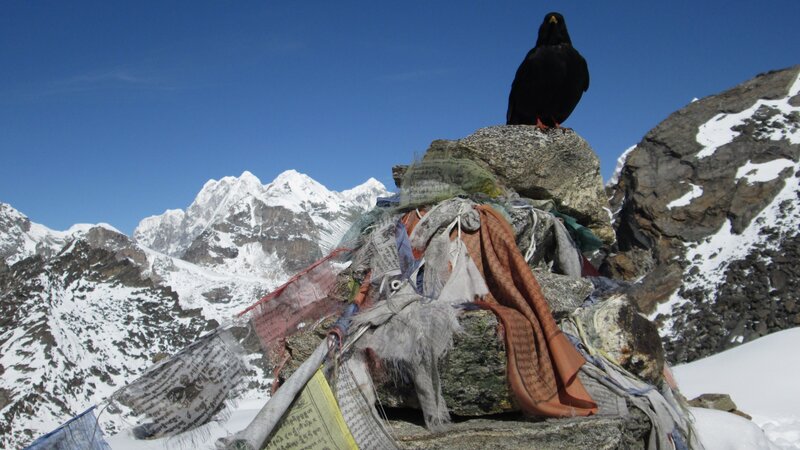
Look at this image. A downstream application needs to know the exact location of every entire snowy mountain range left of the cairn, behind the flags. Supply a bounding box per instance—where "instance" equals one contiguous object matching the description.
[0,171,386,448]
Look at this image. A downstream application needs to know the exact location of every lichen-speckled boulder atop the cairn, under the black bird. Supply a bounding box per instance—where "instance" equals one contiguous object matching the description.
[412,125,614,243]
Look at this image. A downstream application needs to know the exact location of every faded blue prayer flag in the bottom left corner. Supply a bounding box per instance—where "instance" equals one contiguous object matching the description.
[24,406,111,450]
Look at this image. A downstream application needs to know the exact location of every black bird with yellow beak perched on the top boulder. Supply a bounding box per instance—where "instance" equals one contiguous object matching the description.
[506,12,589,129]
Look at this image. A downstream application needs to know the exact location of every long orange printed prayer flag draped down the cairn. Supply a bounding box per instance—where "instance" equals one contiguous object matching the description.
[462,205,597,417]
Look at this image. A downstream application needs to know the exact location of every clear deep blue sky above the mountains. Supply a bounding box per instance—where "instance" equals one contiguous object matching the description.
[0,0,800,233]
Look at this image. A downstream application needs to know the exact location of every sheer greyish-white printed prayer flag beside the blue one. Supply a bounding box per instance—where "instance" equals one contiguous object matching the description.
[112,329,246,439]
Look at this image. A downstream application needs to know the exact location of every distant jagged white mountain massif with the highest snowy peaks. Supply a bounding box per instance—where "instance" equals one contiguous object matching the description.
[133,170,387,275]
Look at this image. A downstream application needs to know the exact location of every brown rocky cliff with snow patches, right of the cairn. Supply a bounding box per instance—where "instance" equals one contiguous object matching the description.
[604,66,800,362]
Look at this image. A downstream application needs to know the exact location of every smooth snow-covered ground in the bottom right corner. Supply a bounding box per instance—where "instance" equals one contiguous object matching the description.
[673,328,800,450]
